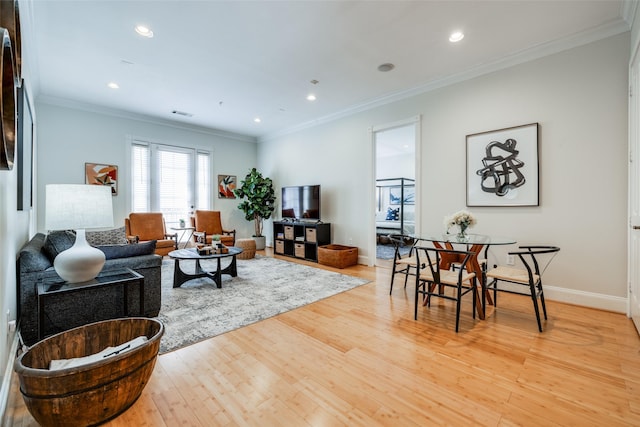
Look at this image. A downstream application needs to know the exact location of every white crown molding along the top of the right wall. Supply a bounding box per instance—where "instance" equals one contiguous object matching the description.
[257,17,636,143]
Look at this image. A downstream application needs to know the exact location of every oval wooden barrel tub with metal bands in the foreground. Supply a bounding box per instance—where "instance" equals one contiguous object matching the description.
[15,318,164,427]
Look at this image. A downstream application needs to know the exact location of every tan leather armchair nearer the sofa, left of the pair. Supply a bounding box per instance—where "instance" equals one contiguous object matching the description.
[124,212,178,256]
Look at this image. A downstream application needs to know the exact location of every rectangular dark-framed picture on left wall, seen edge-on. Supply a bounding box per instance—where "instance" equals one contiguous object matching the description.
[16,81,33,211]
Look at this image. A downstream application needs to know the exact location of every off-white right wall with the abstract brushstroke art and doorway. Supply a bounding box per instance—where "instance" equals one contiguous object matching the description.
[258,33,630,312]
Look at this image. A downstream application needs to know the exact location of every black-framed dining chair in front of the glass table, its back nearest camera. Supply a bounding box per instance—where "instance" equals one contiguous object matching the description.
[413,246,478,332]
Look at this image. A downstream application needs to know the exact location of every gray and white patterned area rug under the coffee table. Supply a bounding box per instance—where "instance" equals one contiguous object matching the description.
[158,257,369,353]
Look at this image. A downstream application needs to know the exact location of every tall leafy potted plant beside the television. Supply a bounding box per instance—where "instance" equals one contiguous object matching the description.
[233,168,276,249]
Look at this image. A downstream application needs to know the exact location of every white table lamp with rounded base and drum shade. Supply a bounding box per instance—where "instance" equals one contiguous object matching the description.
[45,184,113,283]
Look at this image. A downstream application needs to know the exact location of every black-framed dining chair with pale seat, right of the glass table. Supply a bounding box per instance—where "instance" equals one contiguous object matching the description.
[486,246,560,332]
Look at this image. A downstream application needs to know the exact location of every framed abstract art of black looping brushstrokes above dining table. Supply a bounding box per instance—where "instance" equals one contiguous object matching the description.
[467,123,540,206]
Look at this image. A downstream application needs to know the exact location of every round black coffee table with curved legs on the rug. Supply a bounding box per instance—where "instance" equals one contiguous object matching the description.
[169,246,242,288]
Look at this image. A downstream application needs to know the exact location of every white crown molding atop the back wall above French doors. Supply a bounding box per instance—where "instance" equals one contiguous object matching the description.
[38,95,257,143]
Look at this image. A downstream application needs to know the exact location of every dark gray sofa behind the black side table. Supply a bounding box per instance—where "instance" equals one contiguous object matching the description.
[16,231,162,346]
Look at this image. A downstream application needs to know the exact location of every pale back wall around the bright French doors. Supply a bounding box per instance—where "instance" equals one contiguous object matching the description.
[36,102,256,237]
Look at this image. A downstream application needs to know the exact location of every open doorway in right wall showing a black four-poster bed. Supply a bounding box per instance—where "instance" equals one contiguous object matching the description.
[373,120,419,267]
